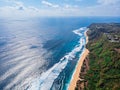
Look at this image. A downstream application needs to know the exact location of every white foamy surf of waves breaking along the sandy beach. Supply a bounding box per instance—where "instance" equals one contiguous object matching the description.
[28,28,86,90]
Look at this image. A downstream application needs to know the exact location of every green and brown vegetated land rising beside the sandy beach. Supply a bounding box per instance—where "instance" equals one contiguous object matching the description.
[85,23,120,90]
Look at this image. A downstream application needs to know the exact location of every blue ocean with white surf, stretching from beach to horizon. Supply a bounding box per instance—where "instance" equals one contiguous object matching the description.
[0,17,120,90]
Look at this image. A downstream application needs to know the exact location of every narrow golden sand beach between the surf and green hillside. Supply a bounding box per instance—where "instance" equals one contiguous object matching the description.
[68,30,89,90]
